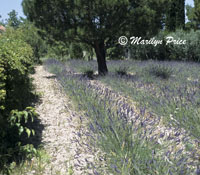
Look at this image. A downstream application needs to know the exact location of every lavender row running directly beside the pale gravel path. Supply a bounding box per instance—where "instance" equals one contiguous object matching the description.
[44,61,199,174]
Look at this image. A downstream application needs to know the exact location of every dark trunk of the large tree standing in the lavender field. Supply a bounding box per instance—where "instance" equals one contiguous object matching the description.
[94,41,108,75]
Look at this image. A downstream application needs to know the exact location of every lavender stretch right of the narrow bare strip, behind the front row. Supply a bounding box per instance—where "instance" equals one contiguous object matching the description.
[100,61,200,139]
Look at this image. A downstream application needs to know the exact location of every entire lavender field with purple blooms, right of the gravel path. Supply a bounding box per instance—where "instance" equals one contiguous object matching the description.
[45,59,200,175]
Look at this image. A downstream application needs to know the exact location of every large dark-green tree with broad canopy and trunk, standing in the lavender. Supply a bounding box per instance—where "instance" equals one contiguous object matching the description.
[22,0,165,75]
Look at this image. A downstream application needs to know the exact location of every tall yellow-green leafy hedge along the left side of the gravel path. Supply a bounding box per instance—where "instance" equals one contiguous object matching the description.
[0,29,36,174]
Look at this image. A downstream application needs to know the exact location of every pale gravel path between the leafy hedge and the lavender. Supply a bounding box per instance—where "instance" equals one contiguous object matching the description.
[33,66,93,175]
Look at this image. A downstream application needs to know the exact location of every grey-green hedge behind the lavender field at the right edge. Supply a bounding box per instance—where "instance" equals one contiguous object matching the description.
[130,30,200,61]
